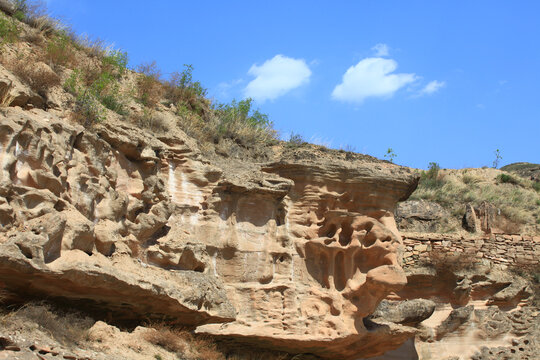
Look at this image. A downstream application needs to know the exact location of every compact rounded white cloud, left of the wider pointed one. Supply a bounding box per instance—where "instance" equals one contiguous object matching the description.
[244,55,311,102]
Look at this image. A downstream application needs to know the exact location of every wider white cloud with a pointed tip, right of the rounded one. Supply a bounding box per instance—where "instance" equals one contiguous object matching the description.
[332,57,417,103]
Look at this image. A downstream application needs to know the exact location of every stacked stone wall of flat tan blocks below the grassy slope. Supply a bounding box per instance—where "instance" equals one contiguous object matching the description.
[402,233,540,267]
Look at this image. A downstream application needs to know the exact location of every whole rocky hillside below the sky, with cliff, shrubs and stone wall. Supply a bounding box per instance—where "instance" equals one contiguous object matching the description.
[0,0,540,360]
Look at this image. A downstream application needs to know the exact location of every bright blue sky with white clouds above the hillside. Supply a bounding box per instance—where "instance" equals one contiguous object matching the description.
[47,0,540,168]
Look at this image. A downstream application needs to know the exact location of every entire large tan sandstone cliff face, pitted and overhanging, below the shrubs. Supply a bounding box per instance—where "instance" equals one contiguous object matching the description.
[0,109,418,359]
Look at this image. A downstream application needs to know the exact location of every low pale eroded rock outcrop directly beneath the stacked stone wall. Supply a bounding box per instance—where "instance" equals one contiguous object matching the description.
[386,263,540,360]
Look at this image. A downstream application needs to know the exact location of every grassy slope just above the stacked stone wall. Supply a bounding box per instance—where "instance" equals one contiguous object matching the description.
[396,167,540,235]
